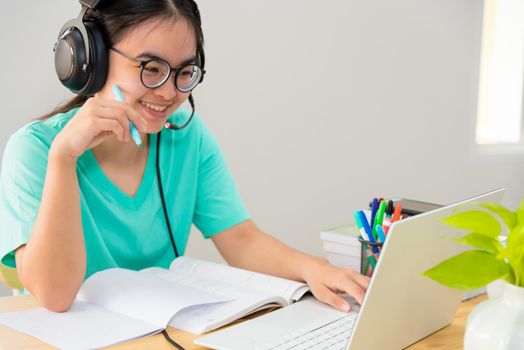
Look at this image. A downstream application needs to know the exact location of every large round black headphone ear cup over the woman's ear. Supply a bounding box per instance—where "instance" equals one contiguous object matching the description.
[53,0,109,96]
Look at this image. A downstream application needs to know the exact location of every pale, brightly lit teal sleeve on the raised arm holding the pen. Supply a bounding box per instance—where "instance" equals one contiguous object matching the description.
[0,124,49,267]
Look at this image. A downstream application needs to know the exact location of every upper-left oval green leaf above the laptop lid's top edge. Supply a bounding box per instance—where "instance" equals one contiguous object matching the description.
[442,210,502,238]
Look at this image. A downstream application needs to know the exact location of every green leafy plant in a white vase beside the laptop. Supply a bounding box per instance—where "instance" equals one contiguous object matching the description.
[423,201,524,350]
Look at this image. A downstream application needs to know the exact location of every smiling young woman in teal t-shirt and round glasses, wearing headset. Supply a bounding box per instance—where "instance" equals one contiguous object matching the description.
[0,0,368,311]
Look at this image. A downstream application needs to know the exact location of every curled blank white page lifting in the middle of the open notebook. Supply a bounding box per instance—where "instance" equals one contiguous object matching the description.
[78,268,226,329]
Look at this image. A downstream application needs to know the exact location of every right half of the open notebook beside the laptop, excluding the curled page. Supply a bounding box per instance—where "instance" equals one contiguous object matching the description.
[149,257,309,334]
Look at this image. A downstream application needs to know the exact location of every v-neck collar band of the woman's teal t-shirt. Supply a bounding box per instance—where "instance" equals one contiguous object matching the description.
[82,134,157,209]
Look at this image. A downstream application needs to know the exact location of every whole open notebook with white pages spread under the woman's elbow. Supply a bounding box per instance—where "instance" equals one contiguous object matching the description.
[0,257,308,349]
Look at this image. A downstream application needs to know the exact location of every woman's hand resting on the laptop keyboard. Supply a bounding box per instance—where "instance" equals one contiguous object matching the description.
[304,258,370,312]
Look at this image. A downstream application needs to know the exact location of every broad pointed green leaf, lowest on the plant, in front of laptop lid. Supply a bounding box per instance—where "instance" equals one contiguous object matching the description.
[422,250,509,290]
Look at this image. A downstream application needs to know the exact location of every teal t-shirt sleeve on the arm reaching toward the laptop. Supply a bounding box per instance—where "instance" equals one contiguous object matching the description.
[193,123,249,238]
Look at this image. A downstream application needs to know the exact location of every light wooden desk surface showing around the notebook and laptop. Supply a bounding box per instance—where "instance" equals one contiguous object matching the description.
[0,295,486,350]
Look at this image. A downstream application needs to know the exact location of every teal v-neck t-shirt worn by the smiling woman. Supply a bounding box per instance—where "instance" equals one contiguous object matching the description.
[0,109,249,278]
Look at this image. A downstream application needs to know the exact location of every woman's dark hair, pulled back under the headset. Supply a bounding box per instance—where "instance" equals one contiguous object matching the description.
[38,0,205,120]
